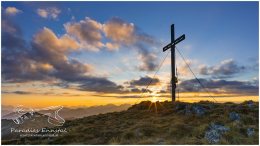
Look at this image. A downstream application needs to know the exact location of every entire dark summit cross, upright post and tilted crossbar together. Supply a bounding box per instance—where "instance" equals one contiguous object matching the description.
[163,24,185,102]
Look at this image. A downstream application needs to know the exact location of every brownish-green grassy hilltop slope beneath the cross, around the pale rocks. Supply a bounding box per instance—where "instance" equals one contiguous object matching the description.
[3,102,259,144]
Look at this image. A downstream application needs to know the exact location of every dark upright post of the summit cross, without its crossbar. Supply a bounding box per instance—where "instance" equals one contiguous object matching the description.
[171,24,176,102]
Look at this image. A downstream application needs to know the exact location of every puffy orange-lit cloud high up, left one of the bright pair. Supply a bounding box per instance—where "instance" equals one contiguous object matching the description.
[64,17,103,51]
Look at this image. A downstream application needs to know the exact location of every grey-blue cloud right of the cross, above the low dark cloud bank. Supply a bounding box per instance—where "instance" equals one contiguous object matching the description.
[199,59,246,78]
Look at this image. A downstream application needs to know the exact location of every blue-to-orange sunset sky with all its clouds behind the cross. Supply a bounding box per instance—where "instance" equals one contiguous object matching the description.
[1,2,259,107]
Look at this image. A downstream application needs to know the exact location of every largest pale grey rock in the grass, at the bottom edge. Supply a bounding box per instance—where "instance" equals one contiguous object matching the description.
[204,124,229,144]
